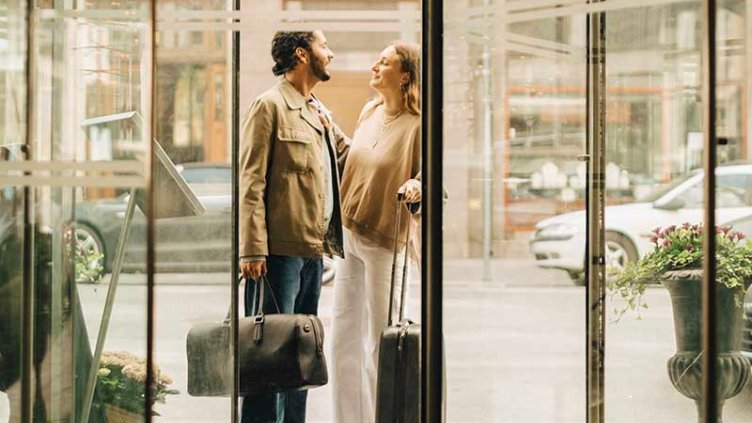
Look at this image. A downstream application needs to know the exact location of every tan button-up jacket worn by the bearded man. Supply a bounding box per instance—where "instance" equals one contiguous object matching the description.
[238,77,350,257]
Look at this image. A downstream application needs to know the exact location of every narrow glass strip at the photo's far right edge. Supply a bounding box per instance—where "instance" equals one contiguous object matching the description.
[715,0,752,421]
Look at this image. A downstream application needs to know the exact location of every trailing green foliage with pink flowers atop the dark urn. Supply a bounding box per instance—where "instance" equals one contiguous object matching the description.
[608,223,752,321]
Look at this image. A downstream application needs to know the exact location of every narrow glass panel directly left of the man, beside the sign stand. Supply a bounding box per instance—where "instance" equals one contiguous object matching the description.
[155,0,236,422]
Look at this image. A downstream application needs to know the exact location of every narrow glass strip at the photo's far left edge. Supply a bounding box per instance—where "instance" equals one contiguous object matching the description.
[0,0,26,422]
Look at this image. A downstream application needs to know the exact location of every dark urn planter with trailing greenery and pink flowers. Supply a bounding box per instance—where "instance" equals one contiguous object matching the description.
[609,223,752,422]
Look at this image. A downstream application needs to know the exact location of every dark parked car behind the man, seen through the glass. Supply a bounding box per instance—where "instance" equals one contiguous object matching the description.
[75,163,334,283]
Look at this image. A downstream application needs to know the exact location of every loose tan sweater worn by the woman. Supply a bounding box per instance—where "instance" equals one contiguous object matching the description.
[341,102,421,249]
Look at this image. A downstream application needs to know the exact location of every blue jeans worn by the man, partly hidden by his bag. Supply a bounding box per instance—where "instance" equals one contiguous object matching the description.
[240,256,324,423]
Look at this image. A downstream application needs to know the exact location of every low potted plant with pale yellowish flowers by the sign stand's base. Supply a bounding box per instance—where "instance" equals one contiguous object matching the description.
[97,351,179,423]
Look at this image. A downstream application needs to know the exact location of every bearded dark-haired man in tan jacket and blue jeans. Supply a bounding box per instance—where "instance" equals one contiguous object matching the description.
[239,31,349,423]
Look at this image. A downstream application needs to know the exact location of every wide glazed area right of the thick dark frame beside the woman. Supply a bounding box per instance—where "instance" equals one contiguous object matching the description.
[434,1,752,422]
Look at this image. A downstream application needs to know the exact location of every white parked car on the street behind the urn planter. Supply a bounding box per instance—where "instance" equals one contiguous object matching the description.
[530,164,752,283]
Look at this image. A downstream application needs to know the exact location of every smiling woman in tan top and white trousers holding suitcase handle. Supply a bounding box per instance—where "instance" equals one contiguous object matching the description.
[332,42,421,423]
